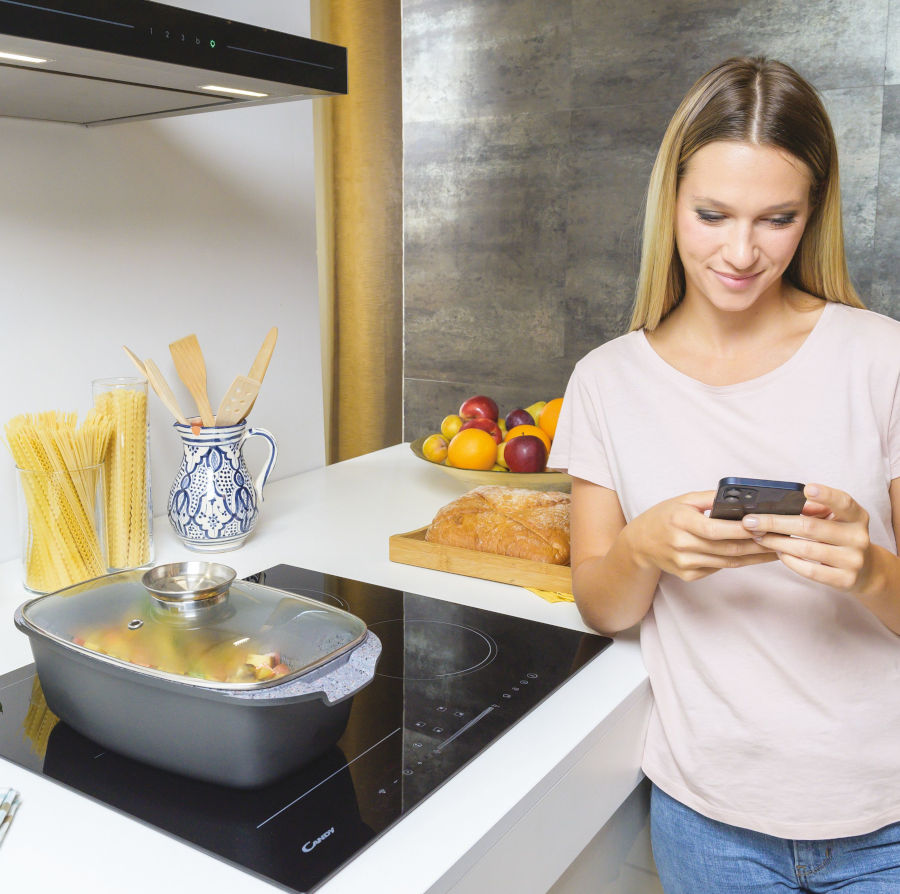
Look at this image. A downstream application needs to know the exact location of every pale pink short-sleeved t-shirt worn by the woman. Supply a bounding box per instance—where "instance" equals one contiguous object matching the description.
[549,303,900,839]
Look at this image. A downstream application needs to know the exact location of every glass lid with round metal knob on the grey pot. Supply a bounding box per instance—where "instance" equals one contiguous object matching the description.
[17,562,366,689]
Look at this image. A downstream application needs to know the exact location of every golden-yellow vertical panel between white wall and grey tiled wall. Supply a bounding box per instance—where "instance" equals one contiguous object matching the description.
[310,0,403,463]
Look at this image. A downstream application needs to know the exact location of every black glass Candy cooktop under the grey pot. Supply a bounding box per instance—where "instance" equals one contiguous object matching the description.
[0,565,612,892]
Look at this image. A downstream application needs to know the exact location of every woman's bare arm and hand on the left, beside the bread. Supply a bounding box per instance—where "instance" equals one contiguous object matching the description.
[570,477,776,633]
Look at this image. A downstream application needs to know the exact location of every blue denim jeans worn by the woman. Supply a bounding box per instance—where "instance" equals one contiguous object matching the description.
[650,785,900,894]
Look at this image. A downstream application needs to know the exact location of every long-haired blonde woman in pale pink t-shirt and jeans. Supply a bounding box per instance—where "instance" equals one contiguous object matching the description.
[550,59,900,894]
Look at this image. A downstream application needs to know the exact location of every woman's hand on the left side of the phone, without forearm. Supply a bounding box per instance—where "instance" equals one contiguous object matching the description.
[623,491,778,581]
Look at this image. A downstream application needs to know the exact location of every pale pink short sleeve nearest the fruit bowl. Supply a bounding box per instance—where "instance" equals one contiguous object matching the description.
[547,360,615,490]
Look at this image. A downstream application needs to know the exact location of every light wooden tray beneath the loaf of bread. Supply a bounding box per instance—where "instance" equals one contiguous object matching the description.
[389,525,572,593]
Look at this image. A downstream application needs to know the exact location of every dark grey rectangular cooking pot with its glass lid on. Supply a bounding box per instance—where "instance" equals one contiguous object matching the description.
[15,562,381,788]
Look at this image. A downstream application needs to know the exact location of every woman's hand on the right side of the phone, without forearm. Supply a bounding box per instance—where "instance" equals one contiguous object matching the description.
[743,484,871,593]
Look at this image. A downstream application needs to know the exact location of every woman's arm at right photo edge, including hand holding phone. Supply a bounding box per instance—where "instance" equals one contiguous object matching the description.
[744,478,900,634]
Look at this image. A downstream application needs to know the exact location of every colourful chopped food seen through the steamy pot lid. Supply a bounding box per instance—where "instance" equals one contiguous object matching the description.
[71,618,293,683]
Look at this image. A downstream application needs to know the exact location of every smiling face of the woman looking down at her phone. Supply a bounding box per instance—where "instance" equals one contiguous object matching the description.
[675,141,812,311]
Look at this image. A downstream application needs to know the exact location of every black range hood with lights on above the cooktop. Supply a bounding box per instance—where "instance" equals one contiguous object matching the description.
[0,0,347,126]
